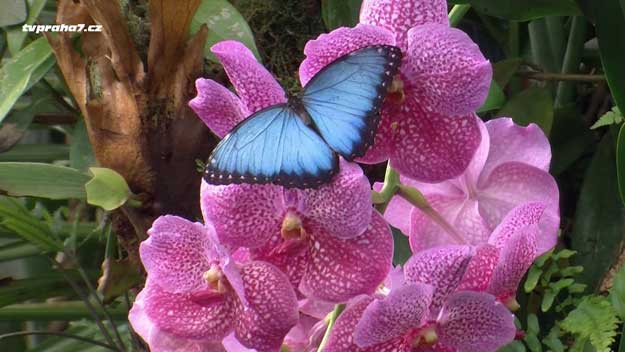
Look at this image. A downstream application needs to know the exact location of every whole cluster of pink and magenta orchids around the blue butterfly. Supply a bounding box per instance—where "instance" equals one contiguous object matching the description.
[129,0,559,352]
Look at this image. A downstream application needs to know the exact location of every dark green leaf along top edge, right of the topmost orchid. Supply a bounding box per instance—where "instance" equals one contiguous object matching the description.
[468,0,580,21]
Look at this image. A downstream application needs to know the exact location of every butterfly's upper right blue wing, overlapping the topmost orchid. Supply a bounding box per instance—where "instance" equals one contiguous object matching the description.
[302,45,401,160]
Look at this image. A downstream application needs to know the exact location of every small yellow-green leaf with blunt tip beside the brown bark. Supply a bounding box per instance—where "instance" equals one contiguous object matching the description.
[85,167,132,210]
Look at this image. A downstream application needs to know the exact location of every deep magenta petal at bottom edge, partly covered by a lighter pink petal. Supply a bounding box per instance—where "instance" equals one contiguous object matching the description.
[323,297,412,352]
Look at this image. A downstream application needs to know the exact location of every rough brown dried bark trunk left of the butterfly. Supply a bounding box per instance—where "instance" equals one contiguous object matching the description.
[48,0,216,260]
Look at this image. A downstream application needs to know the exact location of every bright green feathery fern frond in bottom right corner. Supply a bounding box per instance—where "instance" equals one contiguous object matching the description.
[560,296,619,352]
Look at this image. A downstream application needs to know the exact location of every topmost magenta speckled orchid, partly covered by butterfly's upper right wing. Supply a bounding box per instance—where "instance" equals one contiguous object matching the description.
[299,0,492,182]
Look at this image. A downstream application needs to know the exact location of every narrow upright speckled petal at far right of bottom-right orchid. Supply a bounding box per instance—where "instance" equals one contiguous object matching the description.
[488,225,539,302]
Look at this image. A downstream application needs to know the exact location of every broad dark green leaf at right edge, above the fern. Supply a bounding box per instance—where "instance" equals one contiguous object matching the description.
[570,133,625,291]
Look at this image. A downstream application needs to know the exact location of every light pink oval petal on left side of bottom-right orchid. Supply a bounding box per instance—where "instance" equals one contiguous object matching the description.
[354,283,434,347]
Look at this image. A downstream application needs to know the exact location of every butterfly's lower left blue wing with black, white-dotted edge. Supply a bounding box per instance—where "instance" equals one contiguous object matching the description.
[204,104,338,188]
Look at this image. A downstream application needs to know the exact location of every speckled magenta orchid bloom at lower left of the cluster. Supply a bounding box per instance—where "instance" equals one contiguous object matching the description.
[129,216,298,351]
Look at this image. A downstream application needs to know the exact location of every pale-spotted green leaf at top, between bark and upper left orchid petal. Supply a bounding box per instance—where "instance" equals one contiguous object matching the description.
[189,0,260,62]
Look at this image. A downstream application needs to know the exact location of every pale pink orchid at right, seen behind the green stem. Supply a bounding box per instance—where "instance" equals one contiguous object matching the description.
[374,118,560,255]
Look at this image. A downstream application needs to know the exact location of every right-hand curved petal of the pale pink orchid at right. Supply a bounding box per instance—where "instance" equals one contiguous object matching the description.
[479,162,560,254]
